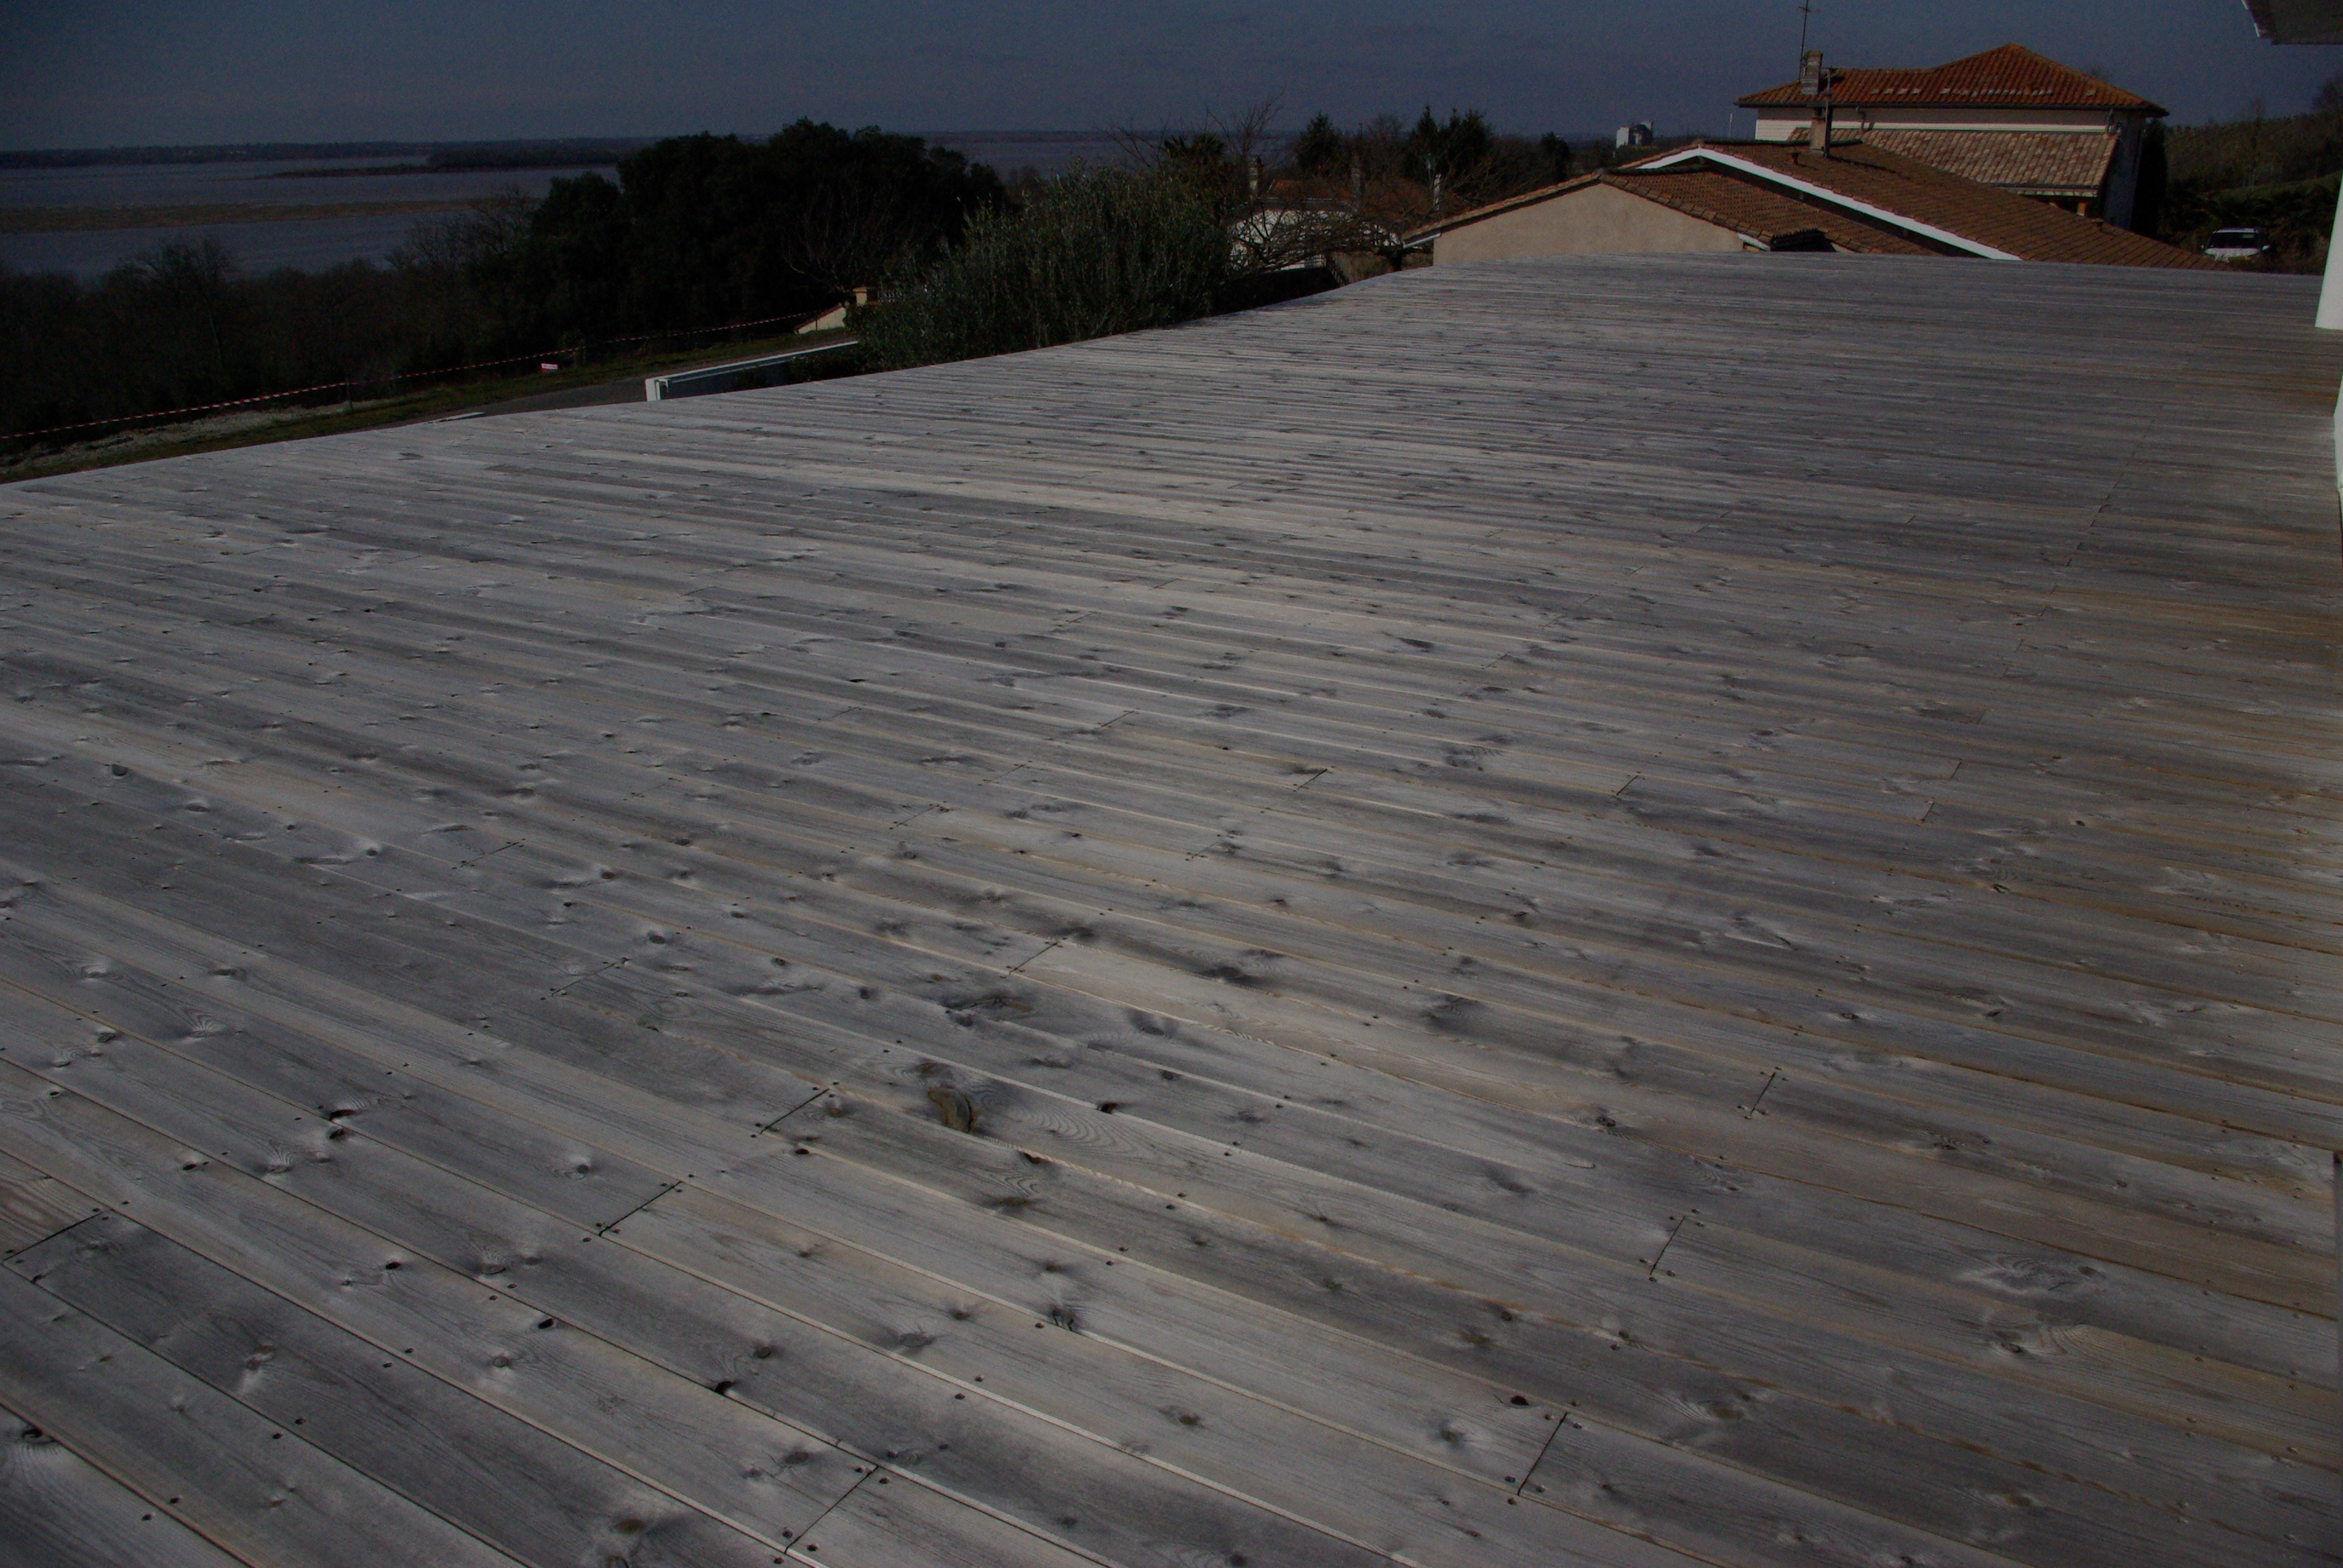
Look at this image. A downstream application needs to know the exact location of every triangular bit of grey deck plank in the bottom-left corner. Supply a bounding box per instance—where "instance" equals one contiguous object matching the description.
[0,1409,237,1568]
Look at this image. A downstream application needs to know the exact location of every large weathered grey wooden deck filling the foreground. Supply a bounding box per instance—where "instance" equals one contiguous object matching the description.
[0,258,2343,1568]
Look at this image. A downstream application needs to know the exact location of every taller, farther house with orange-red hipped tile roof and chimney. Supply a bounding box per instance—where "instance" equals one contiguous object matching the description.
[1741,45,2165,227]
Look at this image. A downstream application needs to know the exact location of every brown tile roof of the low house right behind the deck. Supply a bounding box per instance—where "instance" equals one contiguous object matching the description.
[1408,140,2219,267]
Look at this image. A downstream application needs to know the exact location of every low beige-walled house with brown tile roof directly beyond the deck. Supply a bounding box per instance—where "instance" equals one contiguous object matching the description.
[1413,139,2214,267]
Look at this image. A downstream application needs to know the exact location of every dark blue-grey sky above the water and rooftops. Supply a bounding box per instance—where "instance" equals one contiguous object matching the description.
[0,0,2343,148]
